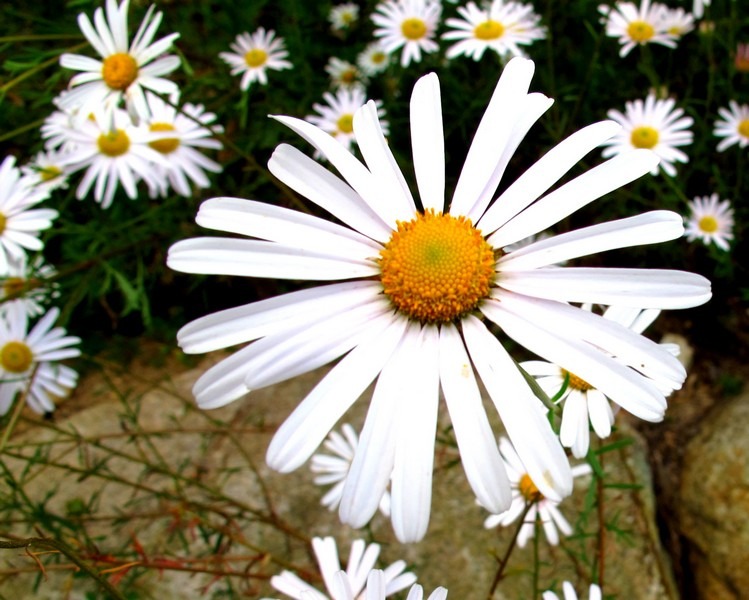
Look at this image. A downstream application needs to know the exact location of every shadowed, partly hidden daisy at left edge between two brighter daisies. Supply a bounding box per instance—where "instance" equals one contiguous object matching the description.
[0,255,60,317]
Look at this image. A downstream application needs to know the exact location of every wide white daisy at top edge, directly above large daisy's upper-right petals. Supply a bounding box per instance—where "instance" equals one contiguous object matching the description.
[442,0,546,60]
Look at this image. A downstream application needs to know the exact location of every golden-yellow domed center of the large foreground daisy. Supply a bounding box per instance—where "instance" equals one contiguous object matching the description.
[379,210,496,323]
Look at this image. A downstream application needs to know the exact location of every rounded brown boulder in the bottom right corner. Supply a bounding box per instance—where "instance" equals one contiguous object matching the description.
[678,393,749,600]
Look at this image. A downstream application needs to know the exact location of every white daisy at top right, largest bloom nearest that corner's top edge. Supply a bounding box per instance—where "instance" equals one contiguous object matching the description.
[598,0,676,57]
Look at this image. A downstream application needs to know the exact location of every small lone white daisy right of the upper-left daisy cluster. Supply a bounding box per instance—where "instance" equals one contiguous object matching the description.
[219,27,293,90]
